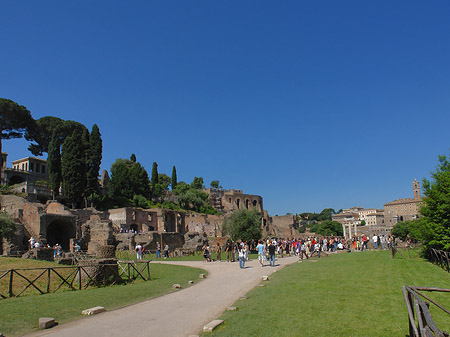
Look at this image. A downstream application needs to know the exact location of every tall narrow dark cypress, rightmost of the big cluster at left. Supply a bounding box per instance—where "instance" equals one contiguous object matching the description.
[86,124,103,202]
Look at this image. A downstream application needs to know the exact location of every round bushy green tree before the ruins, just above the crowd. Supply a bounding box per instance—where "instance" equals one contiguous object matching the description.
[223,208,262,241]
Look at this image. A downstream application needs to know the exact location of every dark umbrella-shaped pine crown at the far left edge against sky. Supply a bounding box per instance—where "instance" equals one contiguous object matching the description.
[0,98,35,167]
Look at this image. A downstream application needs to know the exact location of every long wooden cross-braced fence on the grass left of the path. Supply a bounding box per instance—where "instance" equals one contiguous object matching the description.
[0,261,150,299]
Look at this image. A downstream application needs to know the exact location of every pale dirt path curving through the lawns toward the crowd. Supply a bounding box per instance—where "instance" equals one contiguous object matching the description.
[27,257,298,337]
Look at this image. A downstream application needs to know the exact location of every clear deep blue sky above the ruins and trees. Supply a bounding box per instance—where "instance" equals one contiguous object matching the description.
[0,0,450,215]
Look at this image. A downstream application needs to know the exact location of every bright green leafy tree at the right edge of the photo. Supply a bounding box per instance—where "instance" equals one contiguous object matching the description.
[420,152,450,250]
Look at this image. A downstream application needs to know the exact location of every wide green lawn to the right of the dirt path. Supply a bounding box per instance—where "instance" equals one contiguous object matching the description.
[202,251,450,337]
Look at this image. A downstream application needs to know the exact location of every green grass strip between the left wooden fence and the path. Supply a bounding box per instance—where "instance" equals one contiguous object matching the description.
[0,260,206,336]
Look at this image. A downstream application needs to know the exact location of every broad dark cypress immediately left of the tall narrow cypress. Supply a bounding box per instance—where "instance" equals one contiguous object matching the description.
[61,130,86,204]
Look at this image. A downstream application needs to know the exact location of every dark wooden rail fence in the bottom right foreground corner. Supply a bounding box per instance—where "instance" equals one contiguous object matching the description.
[402,286,450,337]
